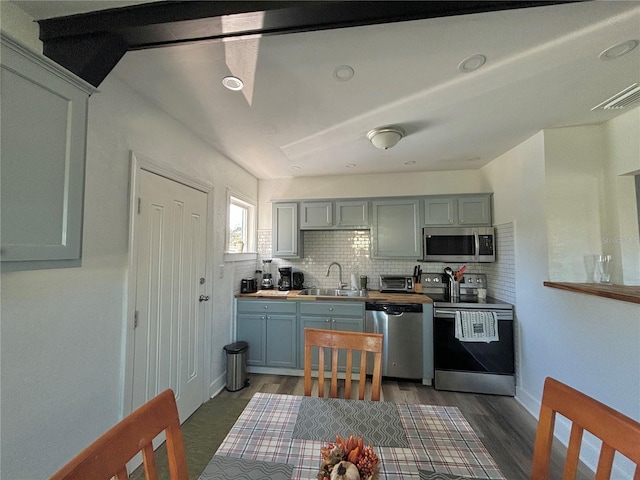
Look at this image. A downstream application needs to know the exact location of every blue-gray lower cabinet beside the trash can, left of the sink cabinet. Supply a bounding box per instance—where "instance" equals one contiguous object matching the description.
[236,299,298,368]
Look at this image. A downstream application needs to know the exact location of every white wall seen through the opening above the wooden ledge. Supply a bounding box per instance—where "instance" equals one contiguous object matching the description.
[544,107,640,285]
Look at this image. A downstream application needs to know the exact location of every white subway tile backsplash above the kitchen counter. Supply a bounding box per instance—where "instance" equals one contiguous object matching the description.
[248,222,516,303]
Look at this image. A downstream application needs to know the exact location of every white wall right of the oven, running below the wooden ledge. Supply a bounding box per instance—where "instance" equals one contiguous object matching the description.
[482,132,640,478]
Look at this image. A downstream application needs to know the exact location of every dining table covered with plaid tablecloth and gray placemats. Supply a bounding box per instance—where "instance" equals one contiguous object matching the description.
[200,393,504,480]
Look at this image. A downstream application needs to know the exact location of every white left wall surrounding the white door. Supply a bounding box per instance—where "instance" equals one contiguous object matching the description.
[1,21,257,480]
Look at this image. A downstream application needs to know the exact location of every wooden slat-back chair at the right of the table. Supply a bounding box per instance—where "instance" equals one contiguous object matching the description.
[531,377,640,480]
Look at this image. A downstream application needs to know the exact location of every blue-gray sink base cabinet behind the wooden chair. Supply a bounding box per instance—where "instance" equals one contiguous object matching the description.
[299,301,364,370]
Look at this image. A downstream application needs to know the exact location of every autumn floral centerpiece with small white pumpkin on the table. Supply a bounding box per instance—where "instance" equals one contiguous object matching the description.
[318,435,380,480]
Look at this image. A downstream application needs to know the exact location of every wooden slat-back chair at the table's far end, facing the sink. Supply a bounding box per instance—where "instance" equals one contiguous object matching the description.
[304,328,383,401]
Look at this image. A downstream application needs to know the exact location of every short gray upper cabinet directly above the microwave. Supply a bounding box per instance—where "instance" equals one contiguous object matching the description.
[424,193,492,227]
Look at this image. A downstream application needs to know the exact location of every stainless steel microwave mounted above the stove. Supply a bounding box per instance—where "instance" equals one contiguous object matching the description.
[422,227,496,263]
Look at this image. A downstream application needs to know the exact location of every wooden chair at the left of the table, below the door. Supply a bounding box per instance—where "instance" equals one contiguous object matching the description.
[50,390,189,480]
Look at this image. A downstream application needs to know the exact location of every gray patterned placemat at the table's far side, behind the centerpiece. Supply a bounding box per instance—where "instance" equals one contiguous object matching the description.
[293,397,409,448]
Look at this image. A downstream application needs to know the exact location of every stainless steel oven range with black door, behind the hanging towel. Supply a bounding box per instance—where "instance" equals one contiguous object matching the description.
[423,273,515,396]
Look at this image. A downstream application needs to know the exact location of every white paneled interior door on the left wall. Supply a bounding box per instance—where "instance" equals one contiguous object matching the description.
[133,170,207,421]
